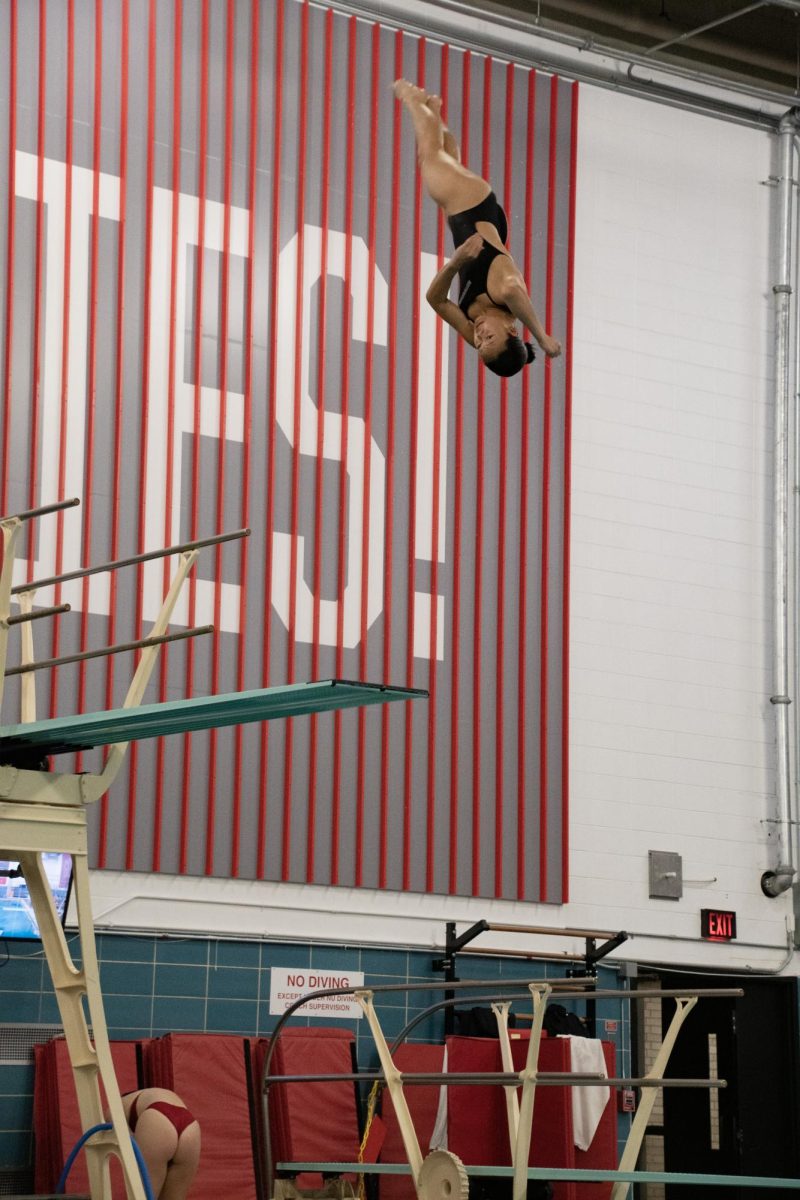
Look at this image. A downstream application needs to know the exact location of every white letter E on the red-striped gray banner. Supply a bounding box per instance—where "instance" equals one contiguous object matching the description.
[142,187,249,634]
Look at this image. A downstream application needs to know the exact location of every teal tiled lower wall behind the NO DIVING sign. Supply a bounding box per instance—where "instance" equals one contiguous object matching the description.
[0,934,630,1170]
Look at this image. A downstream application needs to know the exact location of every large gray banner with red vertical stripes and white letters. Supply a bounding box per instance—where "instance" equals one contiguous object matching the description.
[0,0,578,902]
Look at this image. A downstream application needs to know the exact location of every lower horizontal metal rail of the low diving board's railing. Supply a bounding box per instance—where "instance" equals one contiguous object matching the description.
[264,1070,728,1091]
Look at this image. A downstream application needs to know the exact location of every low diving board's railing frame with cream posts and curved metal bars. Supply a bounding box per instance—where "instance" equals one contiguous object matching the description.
[261,977,786,1200]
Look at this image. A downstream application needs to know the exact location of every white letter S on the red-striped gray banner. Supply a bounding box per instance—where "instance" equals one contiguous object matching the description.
[272,224,387,649]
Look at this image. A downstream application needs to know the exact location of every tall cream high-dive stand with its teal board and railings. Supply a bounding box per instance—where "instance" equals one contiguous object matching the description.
[0,500,427,1200]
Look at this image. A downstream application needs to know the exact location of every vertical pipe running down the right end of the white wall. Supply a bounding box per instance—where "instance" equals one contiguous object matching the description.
[762,108,800,898]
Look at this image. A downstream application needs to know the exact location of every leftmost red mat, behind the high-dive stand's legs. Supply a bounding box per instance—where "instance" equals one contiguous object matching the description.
[34,1038,138,1195]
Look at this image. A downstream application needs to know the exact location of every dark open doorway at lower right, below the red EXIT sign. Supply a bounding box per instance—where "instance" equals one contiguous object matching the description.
[661,973,800,1200]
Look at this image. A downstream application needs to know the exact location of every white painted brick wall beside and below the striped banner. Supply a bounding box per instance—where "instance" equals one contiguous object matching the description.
[86,79,795,971]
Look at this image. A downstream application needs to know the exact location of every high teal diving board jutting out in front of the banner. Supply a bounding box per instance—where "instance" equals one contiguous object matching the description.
[0,679,428,762]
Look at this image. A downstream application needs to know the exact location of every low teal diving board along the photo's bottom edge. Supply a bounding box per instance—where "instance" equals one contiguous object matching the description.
[276,1163,800,1190]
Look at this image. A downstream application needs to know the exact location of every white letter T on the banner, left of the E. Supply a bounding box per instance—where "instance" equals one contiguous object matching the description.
[14,150,120,614]
